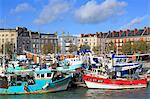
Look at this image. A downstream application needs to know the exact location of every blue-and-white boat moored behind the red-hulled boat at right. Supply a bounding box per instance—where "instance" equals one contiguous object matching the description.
[108,54,143,76]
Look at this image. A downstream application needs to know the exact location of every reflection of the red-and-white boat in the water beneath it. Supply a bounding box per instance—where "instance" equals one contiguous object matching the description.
[85,88,150,99]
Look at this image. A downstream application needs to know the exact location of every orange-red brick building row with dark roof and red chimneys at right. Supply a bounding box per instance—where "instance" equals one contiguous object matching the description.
[103,27,150,54]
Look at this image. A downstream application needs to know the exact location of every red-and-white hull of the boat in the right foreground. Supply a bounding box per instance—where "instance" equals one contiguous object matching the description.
[83,75,147,89]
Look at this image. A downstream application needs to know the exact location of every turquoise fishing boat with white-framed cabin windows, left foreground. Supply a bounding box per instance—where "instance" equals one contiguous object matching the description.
[0,69,71,94]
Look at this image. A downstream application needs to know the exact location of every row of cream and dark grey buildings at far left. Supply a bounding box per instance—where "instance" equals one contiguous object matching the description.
[0,27,58,55]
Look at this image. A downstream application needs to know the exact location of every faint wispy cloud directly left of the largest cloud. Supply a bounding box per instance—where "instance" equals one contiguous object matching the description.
[34,0,70,25]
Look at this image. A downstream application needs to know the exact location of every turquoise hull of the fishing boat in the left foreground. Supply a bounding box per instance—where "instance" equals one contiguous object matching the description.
[0,76,71,95]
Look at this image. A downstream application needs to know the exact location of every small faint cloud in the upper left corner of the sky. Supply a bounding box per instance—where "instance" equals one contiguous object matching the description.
[10,3,35,14]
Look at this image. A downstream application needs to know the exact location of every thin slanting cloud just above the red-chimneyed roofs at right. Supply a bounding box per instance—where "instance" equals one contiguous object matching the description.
[120,15,148,29]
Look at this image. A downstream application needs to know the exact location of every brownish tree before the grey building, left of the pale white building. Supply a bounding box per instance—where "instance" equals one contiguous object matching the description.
[42,44,55,54]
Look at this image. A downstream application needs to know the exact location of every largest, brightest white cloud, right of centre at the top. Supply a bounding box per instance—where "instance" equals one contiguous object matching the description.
[75,0,127,24]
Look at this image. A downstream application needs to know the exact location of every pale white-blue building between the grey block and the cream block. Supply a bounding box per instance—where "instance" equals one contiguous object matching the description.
[58,35,78,54]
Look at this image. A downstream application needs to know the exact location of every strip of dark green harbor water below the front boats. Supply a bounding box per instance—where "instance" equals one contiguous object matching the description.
[0,87,150,99]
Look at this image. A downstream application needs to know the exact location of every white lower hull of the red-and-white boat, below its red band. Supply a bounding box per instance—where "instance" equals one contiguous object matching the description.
[85,81,147,89]
